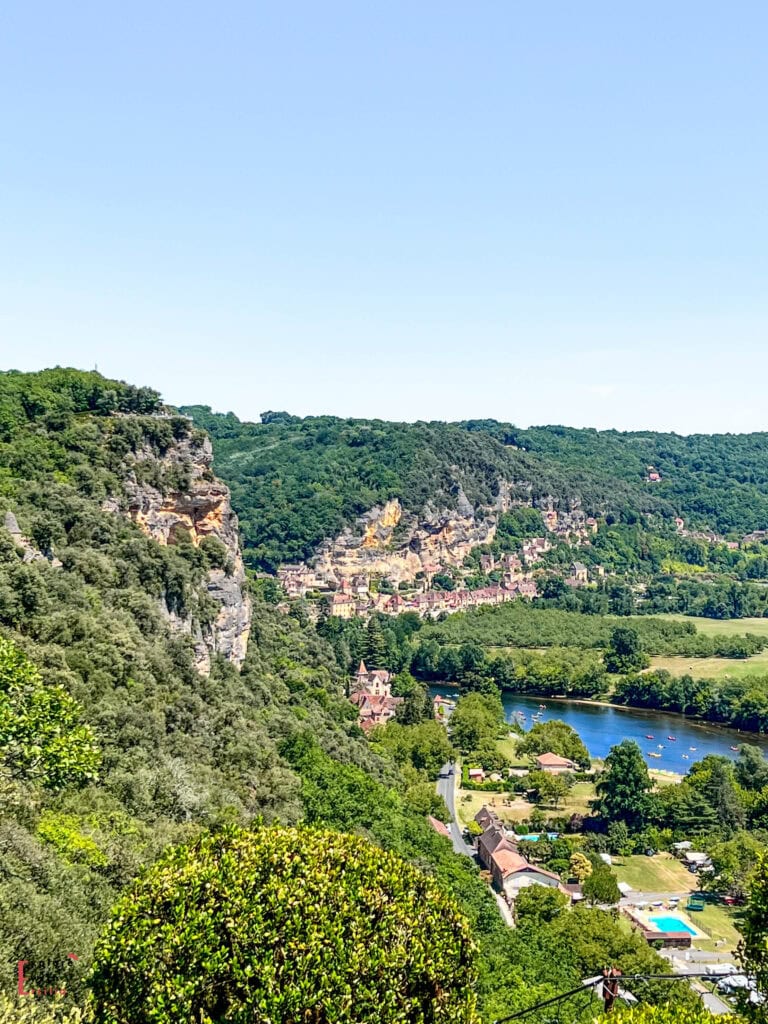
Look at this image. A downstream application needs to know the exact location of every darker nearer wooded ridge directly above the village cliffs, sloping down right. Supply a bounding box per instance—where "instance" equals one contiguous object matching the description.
[181,406,666,568]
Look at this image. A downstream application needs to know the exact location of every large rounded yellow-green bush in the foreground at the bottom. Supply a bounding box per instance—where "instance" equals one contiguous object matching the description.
[90,828,477,1024]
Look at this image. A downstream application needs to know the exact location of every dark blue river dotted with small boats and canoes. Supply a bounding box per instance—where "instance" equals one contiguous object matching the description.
[430,686,768,775]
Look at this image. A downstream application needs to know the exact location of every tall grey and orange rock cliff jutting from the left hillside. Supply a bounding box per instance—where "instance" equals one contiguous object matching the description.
[105,436,251,675]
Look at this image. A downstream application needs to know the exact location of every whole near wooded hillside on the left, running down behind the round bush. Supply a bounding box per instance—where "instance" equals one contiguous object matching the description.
[0,370,692,1021]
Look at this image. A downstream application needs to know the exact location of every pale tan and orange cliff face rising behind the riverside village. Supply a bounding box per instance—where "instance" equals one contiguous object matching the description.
[313,488,501,584]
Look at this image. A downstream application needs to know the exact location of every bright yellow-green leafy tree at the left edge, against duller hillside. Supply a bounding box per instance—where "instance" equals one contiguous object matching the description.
[0,637,100,790]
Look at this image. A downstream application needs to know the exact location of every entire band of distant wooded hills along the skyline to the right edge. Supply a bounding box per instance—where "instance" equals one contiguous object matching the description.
[182,406,768,569]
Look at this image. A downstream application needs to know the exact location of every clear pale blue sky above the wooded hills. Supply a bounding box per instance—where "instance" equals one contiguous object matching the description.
[0,0,768,432]
